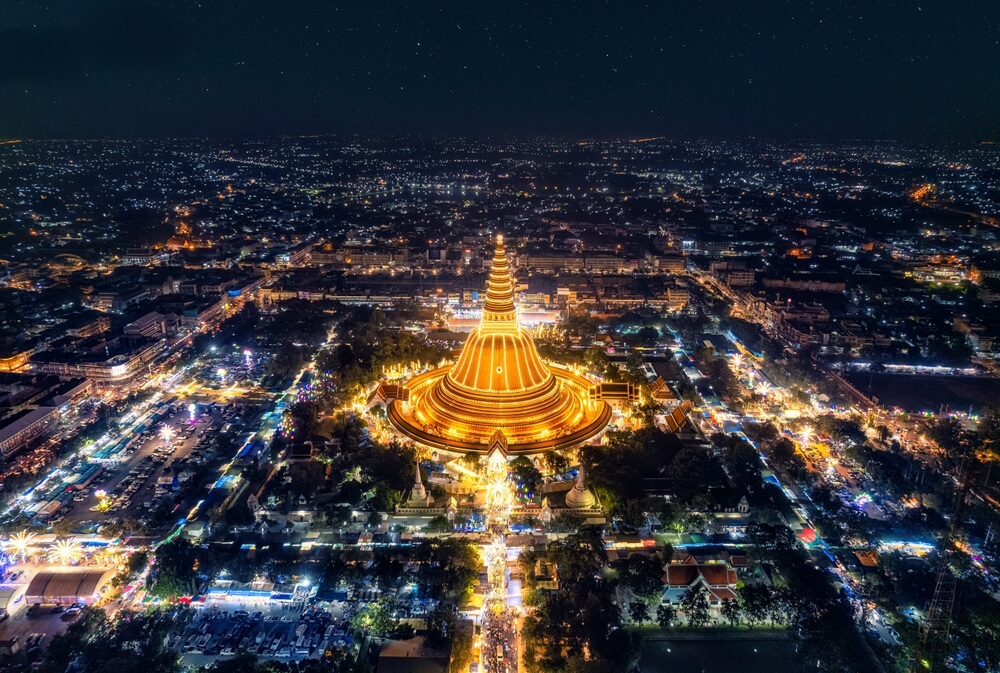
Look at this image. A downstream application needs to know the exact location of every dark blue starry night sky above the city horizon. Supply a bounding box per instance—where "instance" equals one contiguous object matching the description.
[0,0,1000,141]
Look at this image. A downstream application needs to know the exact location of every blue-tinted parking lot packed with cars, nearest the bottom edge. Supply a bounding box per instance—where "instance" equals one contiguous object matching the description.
[169,604,351,665]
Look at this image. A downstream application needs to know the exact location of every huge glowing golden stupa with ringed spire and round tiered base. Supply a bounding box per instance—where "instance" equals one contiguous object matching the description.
[387,236,611,454]
